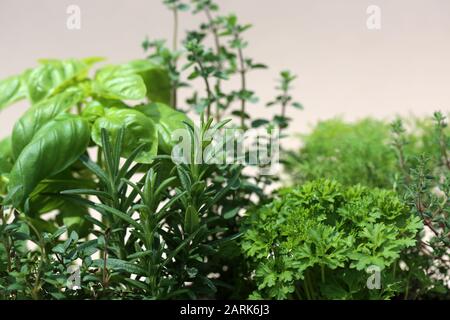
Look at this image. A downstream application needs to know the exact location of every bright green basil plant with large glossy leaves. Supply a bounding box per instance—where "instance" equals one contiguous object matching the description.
[0,58,190,224]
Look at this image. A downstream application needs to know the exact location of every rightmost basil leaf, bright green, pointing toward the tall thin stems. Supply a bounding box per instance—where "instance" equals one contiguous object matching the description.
[136,103,193,154]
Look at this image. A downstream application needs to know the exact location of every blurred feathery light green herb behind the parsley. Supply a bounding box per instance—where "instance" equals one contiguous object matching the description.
[284,119,397,188]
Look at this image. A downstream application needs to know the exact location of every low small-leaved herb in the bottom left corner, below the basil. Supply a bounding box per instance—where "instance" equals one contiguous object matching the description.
[0,208,101,300]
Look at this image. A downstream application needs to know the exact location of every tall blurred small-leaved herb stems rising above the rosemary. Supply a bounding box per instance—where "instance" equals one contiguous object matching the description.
[143,0,302,132]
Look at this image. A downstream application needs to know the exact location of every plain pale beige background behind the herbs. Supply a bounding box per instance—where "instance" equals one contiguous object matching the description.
[0,0,450,141]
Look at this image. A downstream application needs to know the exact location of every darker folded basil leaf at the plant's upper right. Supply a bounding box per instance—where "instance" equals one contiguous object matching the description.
[123,60,171,104]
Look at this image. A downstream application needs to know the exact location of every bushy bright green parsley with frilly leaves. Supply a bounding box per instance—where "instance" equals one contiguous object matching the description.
[242,180,422,299]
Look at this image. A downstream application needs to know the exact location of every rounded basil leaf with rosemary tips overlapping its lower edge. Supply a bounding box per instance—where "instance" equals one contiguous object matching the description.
[92,108,158,163]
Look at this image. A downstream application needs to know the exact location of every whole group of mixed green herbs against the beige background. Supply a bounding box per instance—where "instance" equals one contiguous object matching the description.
[0,0,450,300]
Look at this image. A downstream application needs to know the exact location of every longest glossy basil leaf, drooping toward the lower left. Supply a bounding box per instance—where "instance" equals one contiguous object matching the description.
[7,114,90,208]
